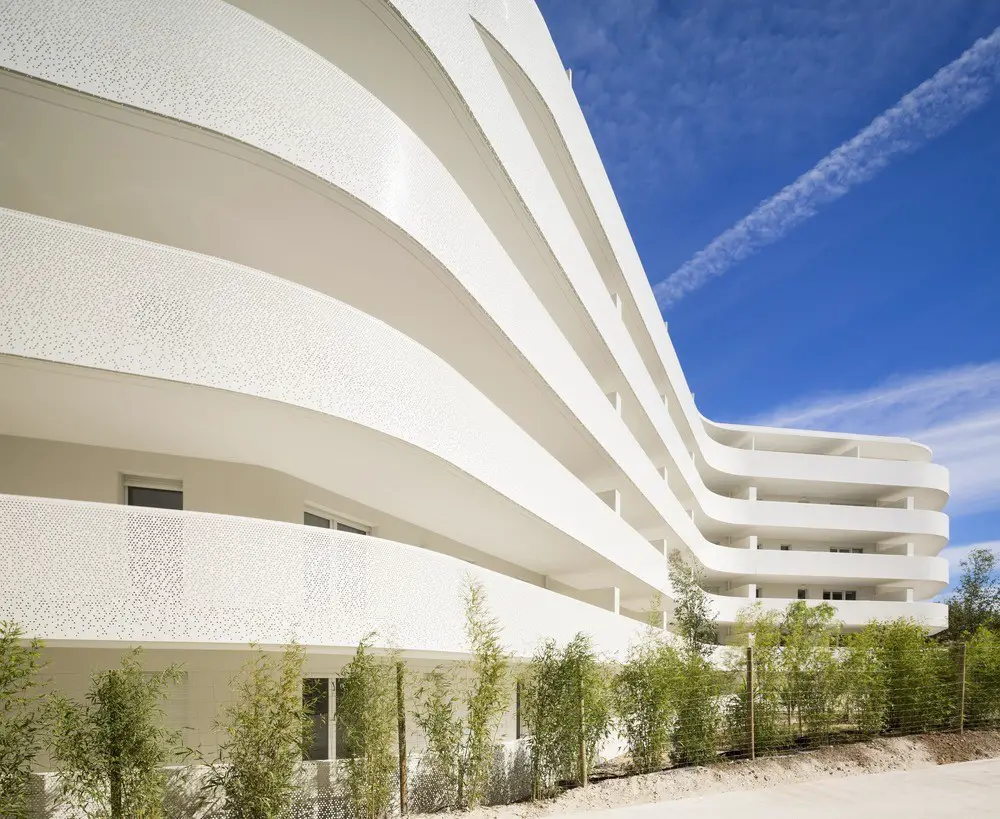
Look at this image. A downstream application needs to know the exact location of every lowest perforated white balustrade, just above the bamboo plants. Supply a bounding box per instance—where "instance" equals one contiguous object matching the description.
[0,495,644,655]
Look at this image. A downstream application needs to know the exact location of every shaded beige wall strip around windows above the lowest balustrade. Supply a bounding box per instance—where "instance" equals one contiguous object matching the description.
[0,435,544,585]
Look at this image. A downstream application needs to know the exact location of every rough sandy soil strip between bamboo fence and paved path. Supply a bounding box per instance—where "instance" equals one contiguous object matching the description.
[416,731,1000,819]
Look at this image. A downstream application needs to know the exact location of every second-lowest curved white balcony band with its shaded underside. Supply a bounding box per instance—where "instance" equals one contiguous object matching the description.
[0,211,666,600]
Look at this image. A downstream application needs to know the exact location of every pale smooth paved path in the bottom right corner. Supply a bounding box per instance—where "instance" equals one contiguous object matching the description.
[578,759,1000,819]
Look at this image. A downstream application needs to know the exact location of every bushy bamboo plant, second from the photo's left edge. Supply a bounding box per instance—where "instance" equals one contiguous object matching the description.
[51,649,182,819]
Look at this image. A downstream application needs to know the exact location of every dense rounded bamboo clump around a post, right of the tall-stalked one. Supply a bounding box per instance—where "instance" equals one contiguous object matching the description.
[521,634,611,797]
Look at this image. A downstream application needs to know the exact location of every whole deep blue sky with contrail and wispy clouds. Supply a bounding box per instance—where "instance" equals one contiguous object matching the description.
[539,0,1000,588]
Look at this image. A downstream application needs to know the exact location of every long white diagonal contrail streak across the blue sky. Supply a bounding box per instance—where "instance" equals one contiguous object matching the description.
[653,28,1000,307]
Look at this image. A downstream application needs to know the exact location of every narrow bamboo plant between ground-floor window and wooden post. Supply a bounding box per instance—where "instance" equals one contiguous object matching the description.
[337,634,399,819]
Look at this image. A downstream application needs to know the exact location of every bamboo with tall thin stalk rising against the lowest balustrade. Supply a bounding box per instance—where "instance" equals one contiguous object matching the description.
[415,581,511,808]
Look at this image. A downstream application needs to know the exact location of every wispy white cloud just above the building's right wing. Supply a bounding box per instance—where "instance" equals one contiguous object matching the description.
[752,361,1000,514]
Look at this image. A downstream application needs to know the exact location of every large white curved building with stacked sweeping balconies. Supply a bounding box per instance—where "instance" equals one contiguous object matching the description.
[0,0,948,764]
